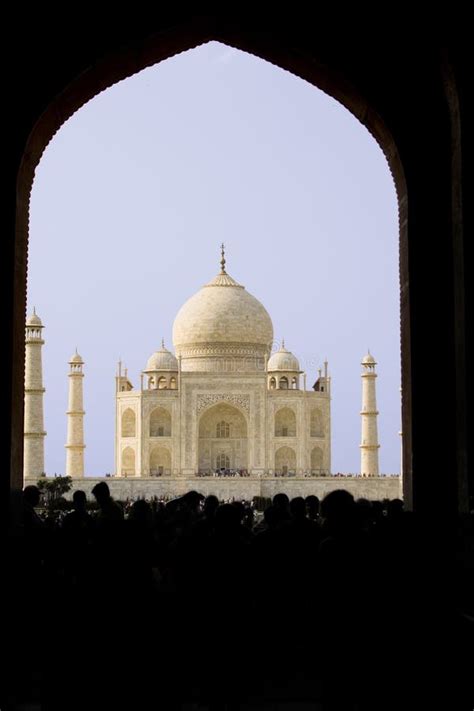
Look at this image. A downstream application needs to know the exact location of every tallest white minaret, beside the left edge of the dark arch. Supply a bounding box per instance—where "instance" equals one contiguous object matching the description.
[23,309,46,479]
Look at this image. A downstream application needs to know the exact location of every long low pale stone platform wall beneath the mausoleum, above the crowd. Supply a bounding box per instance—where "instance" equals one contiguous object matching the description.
[25,476,402,501]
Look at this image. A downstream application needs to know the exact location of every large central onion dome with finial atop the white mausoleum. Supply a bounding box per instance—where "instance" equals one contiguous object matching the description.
[173,250,273,371]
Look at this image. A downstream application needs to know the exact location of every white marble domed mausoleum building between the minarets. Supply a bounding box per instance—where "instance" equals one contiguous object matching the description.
[115,252,331,477]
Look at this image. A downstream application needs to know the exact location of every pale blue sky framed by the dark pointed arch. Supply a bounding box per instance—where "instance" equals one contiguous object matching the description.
[28,42,400,475]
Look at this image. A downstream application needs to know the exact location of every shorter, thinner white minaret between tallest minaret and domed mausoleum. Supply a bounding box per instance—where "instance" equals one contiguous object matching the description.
[66,348,85,478]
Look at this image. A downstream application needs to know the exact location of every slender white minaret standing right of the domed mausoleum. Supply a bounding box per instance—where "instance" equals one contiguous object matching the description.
[360,351,380,476]
